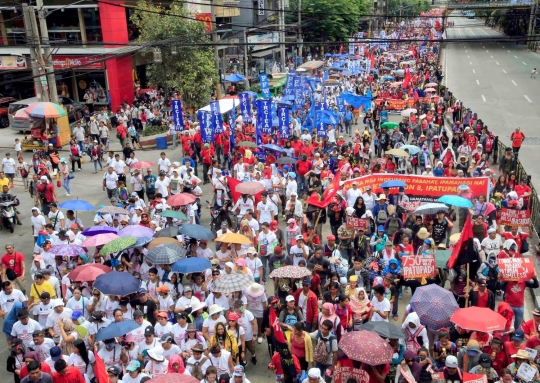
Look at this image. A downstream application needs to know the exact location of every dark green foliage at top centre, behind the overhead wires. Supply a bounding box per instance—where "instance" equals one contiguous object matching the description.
[285,0,371,41]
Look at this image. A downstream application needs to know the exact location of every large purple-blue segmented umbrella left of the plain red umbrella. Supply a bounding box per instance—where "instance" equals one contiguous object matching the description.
[410,284,459,330]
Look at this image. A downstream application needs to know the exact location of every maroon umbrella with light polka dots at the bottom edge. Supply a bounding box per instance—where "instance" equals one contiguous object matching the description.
[339,330,394,366]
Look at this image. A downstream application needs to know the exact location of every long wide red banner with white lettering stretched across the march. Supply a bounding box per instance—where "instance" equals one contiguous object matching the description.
[342,173,489,204]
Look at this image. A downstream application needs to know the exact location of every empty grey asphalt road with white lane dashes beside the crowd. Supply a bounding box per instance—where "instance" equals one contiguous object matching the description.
[442,11,540,190]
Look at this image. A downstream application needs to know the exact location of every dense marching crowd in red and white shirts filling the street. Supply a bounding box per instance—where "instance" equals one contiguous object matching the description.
[0,8,540,383]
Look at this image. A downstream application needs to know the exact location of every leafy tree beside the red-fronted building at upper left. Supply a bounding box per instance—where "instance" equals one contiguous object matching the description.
[131,0,219,109]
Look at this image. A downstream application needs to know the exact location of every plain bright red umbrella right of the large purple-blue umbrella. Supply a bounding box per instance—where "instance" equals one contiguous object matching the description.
[450,306,506,332]
